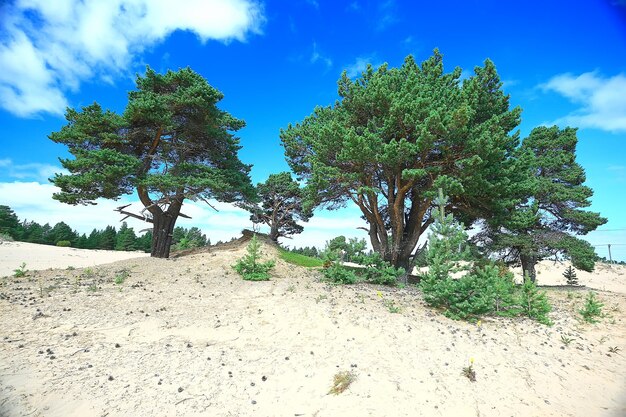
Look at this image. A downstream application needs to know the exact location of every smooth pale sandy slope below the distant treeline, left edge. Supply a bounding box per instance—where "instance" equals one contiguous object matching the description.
[0,242,148,277]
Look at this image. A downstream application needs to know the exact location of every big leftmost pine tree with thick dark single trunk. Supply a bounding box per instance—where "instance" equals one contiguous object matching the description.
[49,68,255,257]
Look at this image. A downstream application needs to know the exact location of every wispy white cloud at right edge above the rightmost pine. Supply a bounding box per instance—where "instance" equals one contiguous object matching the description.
[540,72,626,132]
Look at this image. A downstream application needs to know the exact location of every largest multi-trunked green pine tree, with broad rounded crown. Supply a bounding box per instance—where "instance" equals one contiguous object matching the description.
[280,50,521,268]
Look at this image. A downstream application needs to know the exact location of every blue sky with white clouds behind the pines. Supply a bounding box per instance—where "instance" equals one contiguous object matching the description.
[0,0,626,260]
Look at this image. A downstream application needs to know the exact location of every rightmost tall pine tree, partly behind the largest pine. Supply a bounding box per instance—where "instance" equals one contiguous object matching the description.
[475,126,607,280]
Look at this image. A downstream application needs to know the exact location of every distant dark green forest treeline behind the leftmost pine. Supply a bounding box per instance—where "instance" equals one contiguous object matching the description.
[0,205,210,252]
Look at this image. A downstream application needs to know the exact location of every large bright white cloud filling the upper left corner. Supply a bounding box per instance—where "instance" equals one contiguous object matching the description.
[0,0,265,117]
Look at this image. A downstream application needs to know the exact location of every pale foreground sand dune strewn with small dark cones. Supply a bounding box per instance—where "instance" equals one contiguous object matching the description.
[0,240,626,417]
